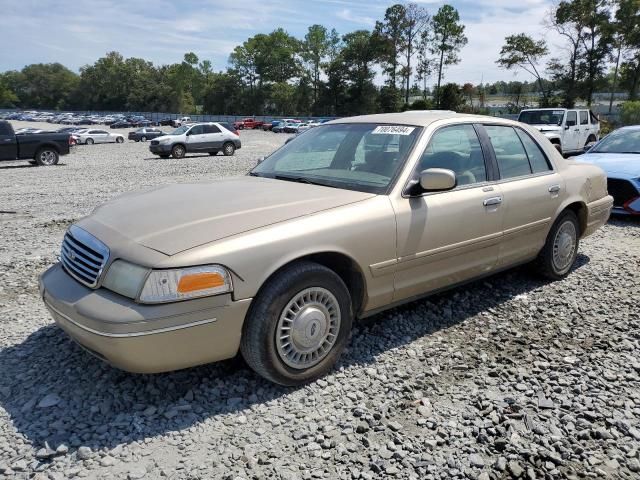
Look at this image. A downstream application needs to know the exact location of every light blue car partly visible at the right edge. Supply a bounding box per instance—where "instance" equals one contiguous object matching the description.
[575,125,640,216]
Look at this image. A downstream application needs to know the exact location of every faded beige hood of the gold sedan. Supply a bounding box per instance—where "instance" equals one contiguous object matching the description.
[89,176,375,255]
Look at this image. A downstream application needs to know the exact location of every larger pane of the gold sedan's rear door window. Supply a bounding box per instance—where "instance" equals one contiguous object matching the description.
[484,125,532,178]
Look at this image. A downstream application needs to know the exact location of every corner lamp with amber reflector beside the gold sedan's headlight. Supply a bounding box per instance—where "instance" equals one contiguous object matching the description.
[140,265,233,303]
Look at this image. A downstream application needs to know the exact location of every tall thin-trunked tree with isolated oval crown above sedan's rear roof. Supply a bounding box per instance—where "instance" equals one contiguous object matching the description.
[424,5,467,106]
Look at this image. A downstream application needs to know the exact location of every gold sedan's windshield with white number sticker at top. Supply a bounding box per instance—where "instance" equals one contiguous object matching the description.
[251,123,421,194]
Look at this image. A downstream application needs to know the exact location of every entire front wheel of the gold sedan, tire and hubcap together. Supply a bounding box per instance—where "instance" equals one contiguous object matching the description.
[240,262,353,386]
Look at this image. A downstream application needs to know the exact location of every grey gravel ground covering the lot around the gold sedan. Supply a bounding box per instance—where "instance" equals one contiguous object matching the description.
[0,122,640,480]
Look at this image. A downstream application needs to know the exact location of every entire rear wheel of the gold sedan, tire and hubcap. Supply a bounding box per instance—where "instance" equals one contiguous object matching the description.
[533,210,580,280]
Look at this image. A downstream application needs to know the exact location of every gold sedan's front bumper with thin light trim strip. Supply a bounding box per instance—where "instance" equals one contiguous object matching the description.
[39,264,251,373]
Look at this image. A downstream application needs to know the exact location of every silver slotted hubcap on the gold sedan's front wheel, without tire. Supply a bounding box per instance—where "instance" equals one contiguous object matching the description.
[276,287,341,369]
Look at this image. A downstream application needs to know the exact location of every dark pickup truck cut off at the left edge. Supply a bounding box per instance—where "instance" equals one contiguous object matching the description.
[0,120,71,166]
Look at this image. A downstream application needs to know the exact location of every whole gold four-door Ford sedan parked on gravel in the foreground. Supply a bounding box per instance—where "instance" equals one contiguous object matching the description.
[40,112,612,385]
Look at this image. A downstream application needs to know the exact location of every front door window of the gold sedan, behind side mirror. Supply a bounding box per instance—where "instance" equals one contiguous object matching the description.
[418,124,487,186]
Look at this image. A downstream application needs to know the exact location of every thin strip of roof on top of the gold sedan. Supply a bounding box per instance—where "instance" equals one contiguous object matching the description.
[323,110,517,127]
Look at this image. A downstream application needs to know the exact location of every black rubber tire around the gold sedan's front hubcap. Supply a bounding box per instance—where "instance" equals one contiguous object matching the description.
[240,261,353,386]
